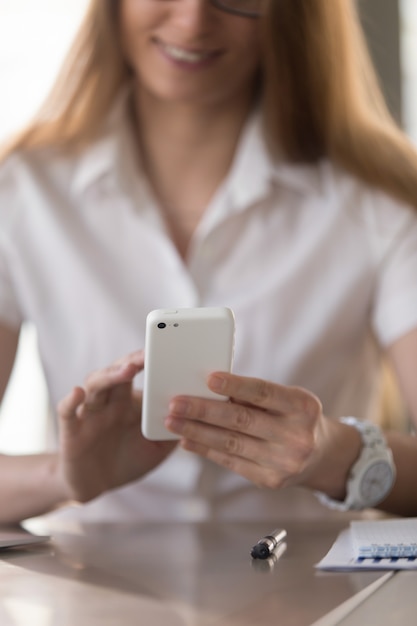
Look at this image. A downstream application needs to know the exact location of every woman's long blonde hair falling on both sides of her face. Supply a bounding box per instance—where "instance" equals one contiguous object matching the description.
[2,0,417,207]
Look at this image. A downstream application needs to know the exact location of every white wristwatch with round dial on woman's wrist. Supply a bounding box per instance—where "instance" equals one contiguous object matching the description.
[316,417,395,511]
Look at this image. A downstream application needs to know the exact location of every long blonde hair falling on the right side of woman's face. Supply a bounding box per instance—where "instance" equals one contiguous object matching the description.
[263,0,417,208]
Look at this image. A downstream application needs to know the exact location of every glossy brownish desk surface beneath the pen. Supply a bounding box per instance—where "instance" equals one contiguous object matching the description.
[0,520,398,626]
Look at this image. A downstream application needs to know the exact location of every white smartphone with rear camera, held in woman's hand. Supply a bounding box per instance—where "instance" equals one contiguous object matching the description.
[142,307,235,441]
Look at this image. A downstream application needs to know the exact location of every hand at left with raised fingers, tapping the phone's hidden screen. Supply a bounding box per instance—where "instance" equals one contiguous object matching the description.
[58,351,176,502]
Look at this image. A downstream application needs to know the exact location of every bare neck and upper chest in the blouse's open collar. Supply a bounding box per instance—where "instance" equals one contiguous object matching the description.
[129,85,252,256]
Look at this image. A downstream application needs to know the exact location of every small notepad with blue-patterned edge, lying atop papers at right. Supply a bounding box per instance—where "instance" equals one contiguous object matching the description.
[350,518,417,559]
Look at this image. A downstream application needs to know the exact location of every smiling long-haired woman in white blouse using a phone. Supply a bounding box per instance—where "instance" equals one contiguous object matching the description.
[0,0,417,522]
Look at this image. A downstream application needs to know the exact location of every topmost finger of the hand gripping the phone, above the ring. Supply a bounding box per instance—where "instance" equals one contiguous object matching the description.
[207,372,321,415]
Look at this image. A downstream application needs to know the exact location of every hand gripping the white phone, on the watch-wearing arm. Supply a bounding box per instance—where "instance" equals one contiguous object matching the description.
[165,372,329,489]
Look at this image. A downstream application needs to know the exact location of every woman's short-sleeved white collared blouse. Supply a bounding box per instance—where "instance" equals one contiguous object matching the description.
[0,102,417,521]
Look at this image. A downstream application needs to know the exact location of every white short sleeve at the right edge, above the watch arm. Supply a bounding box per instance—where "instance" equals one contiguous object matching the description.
[372,193,417,347]
